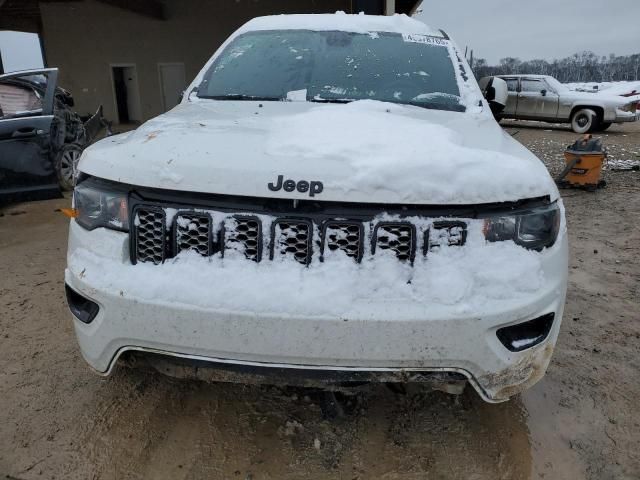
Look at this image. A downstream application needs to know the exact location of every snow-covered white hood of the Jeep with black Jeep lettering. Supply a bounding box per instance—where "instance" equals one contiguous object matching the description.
[79,100,558,205]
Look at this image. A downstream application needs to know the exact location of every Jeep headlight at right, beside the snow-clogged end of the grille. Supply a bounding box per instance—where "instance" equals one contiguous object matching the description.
[483,203,560,251]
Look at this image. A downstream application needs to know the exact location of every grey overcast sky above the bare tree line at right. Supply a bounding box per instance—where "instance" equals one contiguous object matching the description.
[419,0,640,64]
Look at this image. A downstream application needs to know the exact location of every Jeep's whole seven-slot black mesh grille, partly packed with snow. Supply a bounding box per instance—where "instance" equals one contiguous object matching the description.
[131,204,467,265]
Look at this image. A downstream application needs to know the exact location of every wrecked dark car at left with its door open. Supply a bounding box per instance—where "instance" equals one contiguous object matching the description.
[0,68,110,205]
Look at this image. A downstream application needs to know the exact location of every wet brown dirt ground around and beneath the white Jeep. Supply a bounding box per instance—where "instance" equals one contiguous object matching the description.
[0,122,640,480]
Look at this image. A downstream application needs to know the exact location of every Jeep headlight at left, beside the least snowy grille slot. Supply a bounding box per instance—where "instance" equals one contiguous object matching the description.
[73,179,129,232]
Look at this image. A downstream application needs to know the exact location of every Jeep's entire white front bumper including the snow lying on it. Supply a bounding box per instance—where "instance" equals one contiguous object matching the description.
[65,222,567,401]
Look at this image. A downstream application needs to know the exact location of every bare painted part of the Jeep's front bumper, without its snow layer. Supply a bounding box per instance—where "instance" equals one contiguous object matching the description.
[65,221,568,402]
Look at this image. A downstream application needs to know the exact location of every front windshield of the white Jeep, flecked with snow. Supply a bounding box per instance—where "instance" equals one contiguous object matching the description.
[198,30,465,111]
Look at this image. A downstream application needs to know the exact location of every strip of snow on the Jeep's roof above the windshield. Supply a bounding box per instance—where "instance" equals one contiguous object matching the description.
[238,12,443,37]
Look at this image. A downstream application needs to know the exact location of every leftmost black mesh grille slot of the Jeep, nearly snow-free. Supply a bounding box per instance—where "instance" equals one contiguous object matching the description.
[134,207,165,265]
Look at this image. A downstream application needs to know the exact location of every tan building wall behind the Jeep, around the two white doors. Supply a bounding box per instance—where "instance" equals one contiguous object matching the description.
[40,0,352,124]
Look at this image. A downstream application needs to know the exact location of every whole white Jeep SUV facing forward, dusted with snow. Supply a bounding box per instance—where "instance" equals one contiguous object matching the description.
[65,14,567,402]
